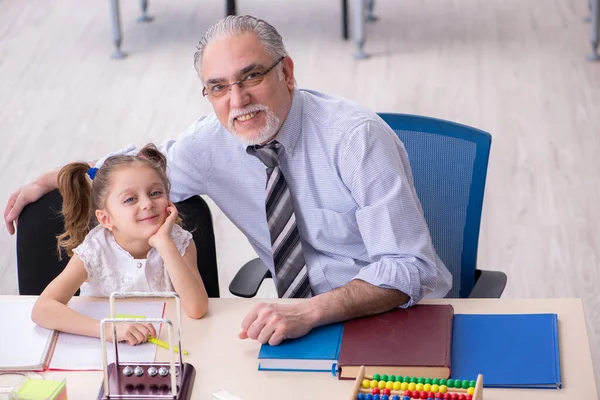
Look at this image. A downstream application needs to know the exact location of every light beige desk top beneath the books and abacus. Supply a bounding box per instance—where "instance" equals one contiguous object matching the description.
[9,296,598,400]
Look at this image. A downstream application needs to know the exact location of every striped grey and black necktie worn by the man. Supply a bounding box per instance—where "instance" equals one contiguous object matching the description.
[248,141,312,298]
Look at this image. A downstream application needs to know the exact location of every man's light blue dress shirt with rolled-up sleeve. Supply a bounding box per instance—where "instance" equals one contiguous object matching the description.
[97,89,452,306]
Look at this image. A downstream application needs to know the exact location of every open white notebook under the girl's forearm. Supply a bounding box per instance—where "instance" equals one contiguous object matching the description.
[0,299,164,371]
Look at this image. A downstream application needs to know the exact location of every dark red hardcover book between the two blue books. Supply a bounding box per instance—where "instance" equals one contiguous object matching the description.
[338,304,454,379]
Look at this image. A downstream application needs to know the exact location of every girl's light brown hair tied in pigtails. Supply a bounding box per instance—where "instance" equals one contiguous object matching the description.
[56,143,175,258]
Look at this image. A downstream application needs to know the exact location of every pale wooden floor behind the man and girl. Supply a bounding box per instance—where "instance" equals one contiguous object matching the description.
[0,0,600,394]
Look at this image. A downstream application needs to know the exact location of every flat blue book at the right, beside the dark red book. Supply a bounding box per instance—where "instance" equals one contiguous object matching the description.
[451,314,562,389]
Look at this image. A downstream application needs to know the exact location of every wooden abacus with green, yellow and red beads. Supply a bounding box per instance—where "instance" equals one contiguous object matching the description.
[350,366,483,400]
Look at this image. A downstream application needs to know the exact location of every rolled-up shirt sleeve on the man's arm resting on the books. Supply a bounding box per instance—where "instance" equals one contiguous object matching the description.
[340,121,452,307]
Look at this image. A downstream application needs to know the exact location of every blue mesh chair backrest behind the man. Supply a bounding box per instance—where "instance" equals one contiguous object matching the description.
[379,113,492,298]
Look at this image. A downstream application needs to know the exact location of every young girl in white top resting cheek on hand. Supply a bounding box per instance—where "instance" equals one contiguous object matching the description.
[31,144,208,345]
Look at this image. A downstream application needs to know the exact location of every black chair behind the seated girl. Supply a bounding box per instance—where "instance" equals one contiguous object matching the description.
[17,190,220,297]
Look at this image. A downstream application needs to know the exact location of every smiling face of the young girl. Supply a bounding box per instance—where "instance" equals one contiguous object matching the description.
[96,165,169,241]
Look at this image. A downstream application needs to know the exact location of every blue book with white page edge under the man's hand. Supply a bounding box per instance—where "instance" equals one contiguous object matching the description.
[258,323,344,375]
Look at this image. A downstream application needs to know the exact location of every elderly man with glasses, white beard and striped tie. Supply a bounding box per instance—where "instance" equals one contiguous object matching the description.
[5,16,452,345]
